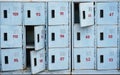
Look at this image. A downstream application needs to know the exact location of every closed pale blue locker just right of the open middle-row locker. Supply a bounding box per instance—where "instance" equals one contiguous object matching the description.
[48,25,69,47]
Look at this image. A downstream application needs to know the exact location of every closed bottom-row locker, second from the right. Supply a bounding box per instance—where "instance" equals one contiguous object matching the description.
[73,48,95,69]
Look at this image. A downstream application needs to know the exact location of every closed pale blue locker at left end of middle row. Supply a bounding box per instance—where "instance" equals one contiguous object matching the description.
[1,25,22,48]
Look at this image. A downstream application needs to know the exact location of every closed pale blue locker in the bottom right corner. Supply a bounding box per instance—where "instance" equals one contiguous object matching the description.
[97,48,117,70]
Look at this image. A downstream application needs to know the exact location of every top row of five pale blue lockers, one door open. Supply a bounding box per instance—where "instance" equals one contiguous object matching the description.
[0,1,119,27]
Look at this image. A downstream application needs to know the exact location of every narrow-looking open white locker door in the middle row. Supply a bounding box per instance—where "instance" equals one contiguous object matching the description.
[34,26,45,50]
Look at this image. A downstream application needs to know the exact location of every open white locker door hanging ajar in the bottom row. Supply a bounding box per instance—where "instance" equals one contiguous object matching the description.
[30,49,45,74]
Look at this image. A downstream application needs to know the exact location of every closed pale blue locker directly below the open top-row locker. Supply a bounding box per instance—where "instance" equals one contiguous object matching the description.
[74,25,94,47]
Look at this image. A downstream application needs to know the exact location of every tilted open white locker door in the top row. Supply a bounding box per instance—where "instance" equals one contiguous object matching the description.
[79,3,94,27]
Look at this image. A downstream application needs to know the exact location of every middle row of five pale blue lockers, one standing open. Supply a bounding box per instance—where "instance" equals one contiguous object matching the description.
[0,25,118,47]
